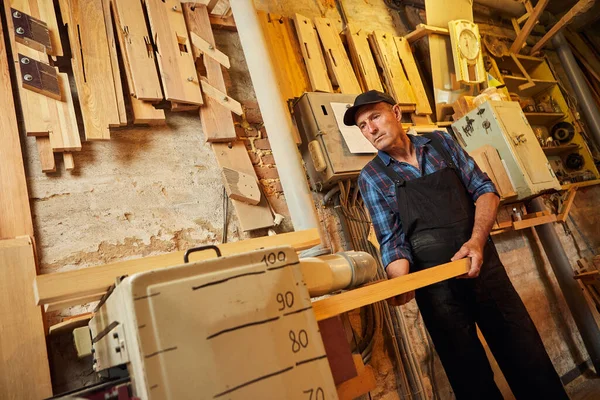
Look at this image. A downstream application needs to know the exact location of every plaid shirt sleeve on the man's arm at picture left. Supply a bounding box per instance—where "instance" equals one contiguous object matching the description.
[358,171,412,268]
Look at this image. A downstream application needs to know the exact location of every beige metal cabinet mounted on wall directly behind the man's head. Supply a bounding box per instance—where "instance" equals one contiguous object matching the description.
[293,93,375,191]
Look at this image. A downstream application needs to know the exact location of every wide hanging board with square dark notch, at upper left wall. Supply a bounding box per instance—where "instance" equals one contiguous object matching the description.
[145,0,203,104]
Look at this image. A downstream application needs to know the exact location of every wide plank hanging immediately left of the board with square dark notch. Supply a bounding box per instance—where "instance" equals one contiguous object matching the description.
[107,0,163,101]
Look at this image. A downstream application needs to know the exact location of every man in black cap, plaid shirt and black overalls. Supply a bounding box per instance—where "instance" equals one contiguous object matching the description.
[344,90,568,400]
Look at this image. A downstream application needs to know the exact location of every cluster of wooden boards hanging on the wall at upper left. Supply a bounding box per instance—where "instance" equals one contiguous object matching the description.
[4,0,242,172]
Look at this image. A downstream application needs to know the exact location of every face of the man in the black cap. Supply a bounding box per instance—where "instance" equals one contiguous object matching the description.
[356,102,404,151]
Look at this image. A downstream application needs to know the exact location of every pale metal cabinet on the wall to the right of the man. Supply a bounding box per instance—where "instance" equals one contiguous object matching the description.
[452,101,560,200]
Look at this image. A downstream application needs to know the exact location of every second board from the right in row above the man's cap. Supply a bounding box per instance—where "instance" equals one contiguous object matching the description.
[369,31,416,104]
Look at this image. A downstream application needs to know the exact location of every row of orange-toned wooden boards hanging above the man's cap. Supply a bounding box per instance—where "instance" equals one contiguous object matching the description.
[258,12,432,125]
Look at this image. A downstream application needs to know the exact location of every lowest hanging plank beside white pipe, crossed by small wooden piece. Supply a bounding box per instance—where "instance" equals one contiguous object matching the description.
[212,141,274,232]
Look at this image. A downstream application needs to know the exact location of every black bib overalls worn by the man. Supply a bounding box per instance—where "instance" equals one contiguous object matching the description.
[374,134,568,400]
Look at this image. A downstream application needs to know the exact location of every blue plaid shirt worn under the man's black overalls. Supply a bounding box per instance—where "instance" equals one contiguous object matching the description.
[358,131,498,268]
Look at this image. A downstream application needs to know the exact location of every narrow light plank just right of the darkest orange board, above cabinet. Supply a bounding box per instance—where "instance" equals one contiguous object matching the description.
[294,14,333,93]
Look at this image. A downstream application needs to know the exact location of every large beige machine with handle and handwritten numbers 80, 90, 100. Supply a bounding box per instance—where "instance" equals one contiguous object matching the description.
[57,246,377,400]
